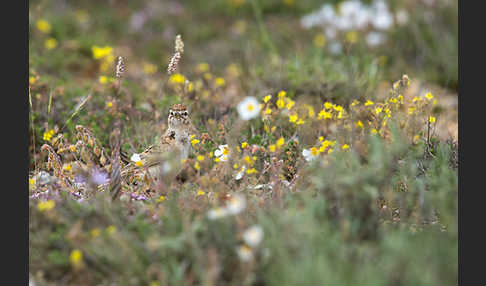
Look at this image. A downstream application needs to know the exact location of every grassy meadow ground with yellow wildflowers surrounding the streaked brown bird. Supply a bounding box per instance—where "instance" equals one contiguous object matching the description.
[29,0,458,285]
